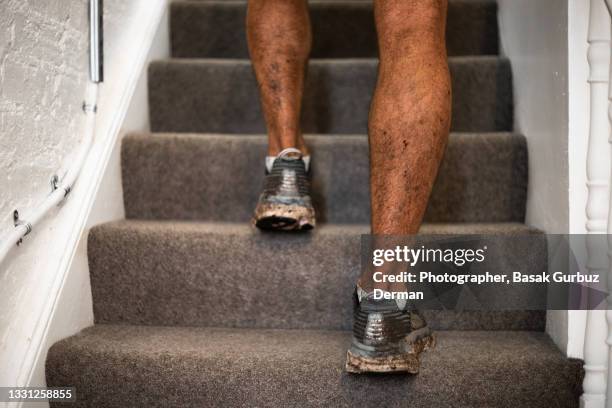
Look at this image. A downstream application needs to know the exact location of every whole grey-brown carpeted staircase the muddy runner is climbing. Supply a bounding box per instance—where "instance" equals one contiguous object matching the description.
[47,0,582,407]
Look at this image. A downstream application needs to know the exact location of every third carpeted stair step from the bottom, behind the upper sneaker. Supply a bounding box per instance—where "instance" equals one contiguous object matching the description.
[121,133,527,224]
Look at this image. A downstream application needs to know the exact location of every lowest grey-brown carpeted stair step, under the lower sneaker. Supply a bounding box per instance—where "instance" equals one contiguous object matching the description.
[46,325,583,408]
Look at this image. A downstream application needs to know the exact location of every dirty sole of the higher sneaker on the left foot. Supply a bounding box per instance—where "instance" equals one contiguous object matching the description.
[253,204,315,231]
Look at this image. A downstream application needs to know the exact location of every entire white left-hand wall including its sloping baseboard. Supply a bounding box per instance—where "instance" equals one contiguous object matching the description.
[0,0,167,392]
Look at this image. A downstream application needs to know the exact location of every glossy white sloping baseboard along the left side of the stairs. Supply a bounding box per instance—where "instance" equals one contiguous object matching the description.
[17,0,168,406]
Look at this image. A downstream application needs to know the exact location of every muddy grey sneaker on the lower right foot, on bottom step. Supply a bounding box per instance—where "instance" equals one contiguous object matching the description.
[346,286,435,374]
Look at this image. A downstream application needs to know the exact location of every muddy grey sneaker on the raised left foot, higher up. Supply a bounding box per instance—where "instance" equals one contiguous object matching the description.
[253,148,315,231]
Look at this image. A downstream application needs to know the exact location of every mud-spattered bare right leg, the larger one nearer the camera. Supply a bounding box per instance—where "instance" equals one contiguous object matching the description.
[362,0,451,290]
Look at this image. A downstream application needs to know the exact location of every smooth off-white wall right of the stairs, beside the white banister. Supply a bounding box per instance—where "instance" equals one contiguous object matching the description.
[499,0,572,350]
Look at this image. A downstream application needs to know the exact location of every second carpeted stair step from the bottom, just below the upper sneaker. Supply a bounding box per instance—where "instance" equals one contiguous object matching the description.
[88,220,547,330]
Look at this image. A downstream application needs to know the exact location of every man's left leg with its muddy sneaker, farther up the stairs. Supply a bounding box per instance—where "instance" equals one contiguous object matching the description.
[247,0,315,230]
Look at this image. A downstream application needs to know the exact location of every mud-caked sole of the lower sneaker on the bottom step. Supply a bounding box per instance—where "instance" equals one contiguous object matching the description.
[345,333,436,374]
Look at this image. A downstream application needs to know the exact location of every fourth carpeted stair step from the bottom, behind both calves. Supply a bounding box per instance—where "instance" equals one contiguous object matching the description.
[149,57,513,134]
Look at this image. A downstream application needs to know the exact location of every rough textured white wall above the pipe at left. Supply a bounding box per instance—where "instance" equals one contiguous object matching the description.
[0,0,88,234]
